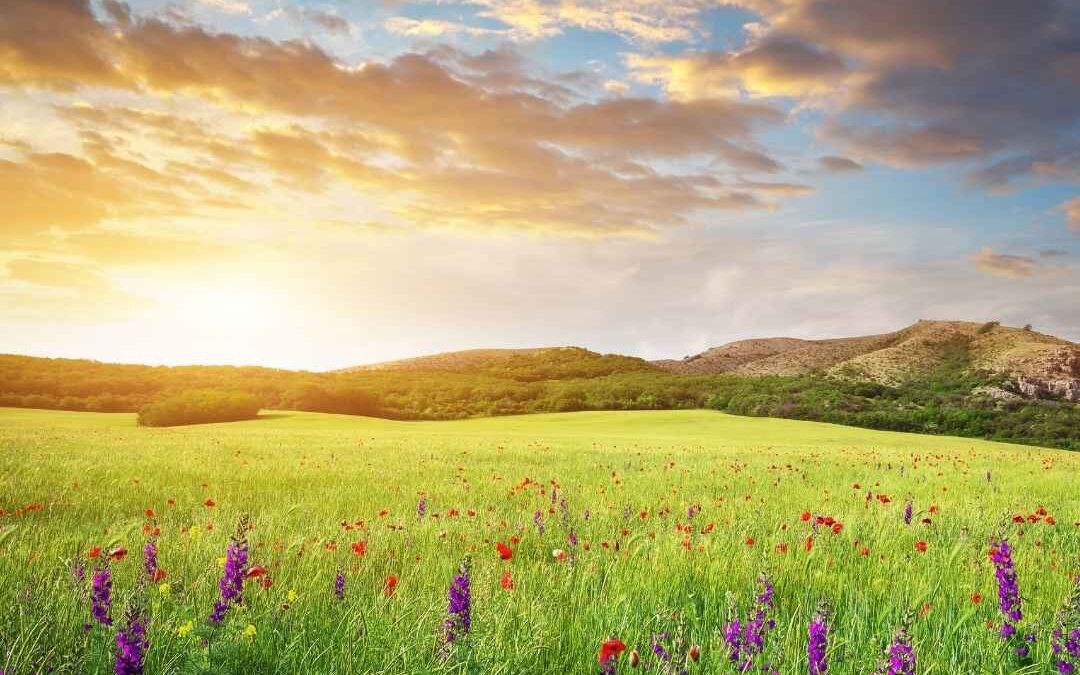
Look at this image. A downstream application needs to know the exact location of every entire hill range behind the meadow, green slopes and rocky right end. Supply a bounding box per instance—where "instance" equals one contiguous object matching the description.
[0,322,1080,449]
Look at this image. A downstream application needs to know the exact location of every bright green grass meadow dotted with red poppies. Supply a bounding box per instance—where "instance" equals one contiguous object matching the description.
[0,409,1080,675]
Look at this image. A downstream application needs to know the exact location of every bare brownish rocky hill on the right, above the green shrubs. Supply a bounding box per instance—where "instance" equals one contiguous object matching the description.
[654,321,1080,401]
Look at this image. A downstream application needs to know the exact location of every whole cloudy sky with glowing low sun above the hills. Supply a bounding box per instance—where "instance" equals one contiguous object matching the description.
[0,0,1080,370]
